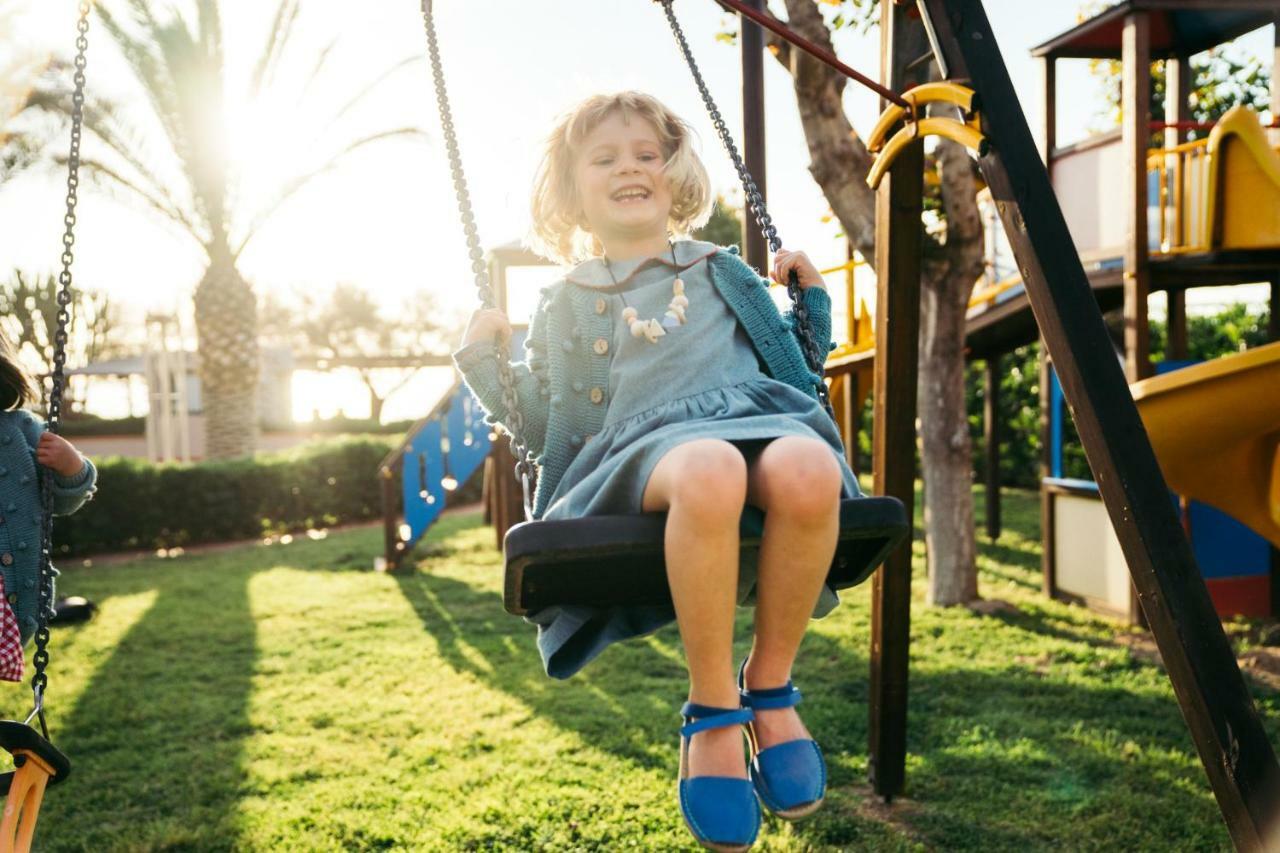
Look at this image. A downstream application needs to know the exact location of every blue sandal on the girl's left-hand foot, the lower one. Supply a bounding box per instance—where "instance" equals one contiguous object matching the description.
[677,702,760,853]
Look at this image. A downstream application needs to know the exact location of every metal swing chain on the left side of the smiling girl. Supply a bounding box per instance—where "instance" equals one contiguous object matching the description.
[422,0,534,519]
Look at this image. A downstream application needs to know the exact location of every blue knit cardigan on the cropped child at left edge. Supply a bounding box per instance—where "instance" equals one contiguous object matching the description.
[0,409,97,642]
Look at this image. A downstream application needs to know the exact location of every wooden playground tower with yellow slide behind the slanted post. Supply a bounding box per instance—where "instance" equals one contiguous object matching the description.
[1024,3,1280,624]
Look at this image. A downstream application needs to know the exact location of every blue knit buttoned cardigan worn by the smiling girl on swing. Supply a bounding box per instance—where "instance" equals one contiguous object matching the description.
[453,247,831,517]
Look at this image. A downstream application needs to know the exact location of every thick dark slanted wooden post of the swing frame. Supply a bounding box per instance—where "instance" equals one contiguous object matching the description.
[922,0,1280,850]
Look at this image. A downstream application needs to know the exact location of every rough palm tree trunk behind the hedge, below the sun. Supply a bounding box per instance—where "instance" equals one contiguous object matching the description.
[196,252,259,460]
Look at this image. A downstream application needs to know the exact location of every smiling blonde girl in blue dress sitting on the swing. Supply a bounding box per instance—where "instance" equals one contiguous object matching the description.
[454,92,859,850]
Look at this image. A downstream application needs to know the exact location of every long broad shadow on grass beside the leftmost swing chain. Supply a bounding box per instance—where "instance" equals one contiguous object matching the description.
[40,552,269,850]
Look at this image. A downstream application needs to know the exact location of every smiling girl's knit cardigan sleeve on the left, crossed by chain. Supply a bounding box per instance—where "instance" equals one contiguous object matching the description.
[453,289,550,459]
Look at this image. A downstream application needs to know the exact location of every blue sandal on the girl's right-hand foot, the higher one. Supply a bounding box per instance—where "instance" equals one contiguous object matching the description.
[737,661,827,821]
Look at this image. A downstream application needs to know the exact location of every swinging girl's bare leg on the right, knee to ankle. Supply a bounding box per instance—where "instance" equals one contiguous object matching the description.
[745,435,841,748]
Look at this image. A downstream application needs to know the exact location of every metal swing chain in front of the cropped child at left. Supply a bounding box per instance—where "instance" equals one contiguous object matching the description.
[27,3,90,739]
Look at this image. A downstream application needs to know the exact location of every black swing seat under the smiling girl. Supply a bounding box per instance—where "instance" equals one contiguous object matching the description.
[503,497,910,616]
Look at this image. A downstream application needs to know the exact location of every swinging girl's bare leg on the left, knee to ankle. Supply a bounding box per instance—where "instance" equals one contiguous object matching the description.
[644,439,746,779]
